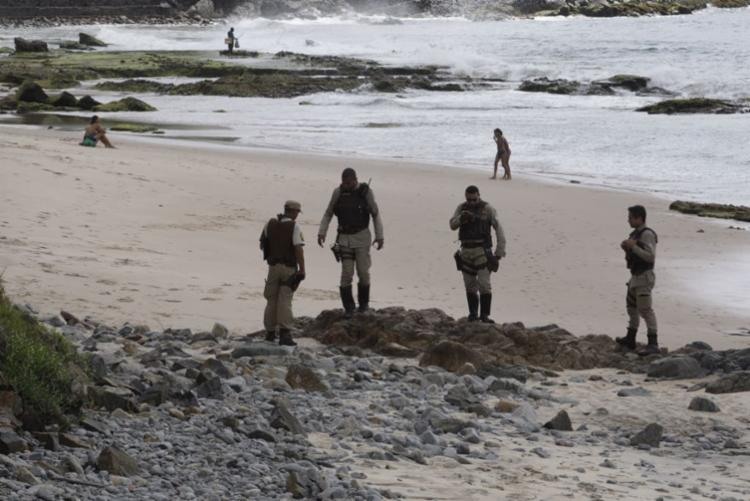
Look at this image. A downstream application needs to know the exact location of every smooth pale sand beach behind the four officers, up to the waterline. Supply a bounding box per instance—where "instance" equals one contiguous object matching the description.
[0,123,750,348]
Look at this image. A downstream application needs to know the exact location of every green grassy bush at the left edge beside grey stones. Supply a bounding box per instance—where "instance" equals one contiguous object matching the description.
[0,283,85,427]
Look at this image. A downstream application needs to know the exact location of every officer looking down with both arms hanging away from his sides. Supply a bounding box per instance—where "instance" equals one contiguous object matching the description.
[318,167,383,318]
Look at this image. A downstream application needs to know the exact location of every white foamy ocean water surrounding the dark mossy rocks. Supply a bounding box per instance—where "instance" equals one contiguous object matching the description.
[0,9,750,205]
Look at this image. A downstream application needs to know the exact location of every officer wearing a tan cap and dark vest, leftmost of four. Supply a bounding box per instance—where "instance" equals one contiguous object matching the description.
[260,200,305,346]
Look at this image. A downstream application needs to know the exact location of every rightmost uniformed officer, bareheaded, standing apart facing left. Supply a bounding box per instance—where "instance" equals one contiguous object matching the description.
[616,205,659,355]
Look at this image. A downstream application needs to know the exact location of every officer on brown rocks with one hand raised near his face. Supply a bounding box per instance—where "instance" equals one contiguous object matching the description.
[450,186,505,323]
